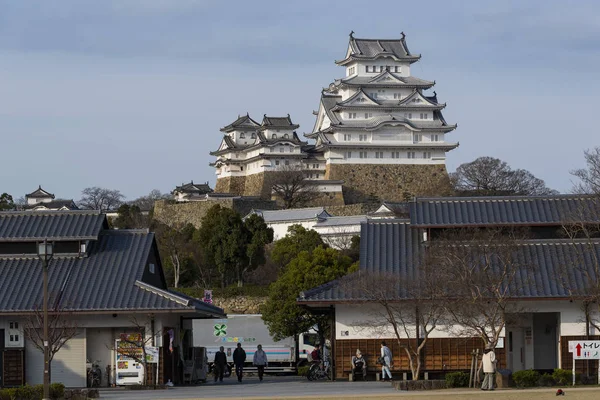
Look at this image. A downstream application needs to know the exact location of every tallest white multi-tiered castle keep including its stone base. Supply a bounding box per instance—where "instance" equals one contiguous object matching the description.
[305,34,458,203]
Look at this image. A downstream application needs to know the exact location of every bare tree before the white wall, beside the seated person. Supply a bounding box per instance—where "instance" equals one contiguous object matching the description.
[345,261,449,380]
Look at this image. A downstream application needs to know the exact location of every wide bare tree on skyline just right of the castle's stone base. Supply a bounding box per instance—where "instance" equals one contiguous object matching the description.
[451,157,558,196]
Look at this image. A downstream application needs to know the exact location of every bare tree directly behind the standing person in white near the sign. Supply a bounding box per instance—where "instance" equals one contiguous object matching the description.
[427,229,536,347]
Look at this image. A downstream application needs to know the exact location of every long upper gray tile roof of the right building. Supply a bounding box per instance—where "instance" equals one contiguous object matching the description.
[410,195,598,227]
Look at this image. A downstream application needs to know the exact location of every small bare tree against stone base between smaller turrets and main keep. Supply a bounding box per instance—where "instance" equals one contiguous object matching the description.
[270,165,321,208]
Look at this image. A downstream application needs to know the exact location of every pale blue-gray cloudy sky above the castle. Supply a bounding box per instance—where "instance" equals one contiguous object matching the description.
[0,0,600,200]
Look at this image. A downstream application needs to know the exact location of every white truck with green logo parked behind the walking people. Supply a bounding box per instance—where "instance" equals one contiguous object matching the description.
[192,314,317,375]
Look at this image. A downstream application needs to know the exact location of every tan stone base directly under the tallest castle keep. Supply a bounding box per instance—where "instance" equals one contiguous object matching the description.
[325,164,451,204]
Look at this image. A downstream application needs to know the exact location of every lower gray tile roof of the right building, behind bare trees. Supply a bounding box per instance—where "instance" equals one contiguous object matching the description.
[298,220,600,304]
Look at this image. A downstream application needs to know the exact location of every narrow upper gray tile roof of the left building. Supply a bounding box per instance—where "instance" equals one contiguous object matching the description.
[0,211,107,242]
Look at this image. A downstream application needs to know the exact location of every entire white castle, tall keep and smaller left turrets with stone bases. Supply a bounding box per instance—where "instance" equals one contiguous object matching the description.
[211,33,458,205]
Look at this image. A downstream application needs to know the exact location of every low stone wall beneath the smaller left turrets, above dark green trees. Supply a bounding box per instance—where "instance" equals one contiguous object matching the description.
[154,198,276,228]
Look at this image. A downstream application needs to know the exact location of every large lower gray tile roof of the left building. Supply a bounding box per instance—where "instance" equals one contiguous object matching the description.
[0,230,223,316]
